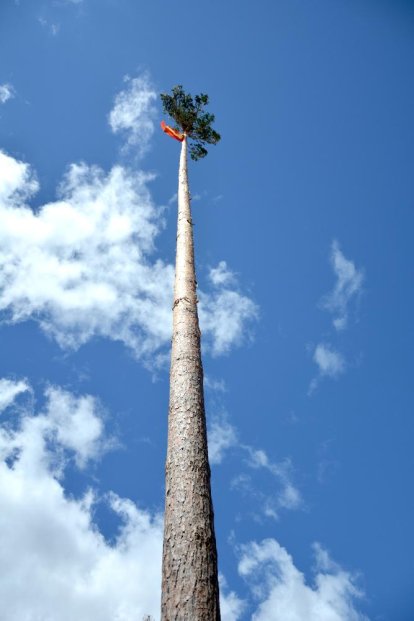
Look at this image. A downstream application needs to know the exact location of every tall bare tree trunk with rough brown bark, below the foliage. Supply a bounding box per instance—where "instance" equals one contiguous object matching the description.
[161,138,220,621]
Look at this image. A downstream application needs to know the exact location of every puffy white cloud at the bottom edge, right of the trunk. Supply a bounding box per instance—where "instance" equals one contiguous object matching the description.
[239,539,367,621]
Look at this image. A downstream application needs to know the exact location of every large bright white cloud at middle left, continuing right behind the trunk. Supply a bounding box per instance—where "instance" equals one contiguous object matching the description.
[0,152,257,364]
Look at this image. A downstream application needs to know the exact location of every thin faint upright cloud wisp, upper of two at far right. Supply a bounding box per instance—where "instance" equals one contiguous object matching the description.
[322,240,364,330]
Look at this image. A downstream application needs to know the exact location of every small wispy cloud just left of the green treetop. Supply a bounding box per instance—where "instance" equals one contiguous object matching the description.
[109,74,157,155]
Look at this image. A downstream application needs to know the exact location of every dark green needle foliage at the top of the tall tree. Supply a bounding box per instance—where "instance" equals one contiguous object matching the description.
[161,84,220,160]
